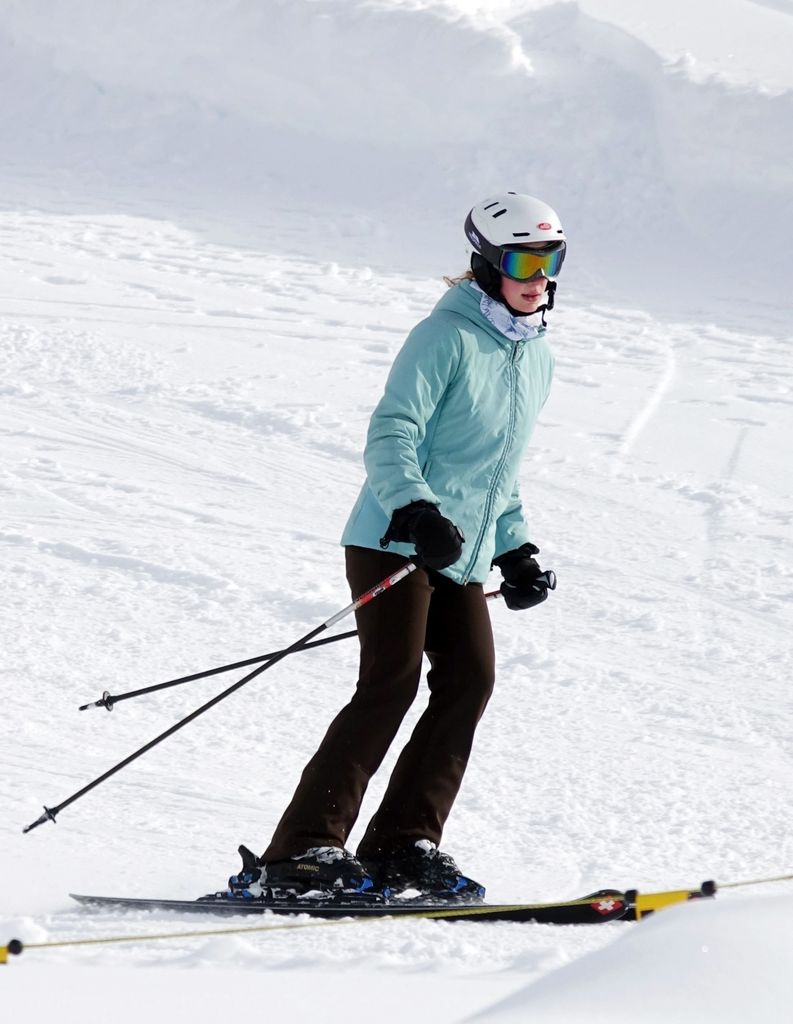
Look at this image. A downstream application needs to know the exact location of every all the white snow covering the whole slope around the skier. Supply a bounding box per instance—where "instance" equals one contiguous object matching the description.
[0,0,793,1022]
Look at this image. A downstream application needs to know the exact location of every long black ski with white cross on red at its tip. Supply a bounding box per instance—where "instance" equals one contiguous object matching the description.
[70,889,632,925]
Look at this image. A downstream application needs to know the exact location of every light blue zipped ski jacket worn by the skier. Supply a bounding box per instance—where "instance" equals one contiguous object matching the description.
[341,281,553,584]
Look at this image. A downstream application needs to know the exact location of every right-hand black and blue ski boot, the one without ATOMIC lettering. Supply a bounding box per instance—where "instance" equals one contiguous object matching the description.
[362,839,485,903]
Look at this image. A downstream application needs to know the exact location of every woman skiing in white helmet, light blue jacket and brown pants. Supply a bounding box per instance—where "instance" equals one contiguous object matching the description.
[227,193,567,898]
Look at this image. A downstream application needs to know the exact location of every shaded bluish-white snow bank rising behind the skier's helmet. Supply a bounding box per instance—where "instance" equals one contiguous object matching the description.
[0,0,793,302]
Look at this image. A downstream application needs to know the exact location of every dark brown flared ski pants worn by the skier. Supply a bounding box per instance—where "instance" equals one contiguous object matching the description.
[262,547,495,861]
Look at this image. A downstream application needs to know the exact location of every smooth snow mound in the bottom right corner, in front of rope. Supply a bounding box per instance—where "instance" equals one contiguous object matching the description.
[468,895,793,1024]
